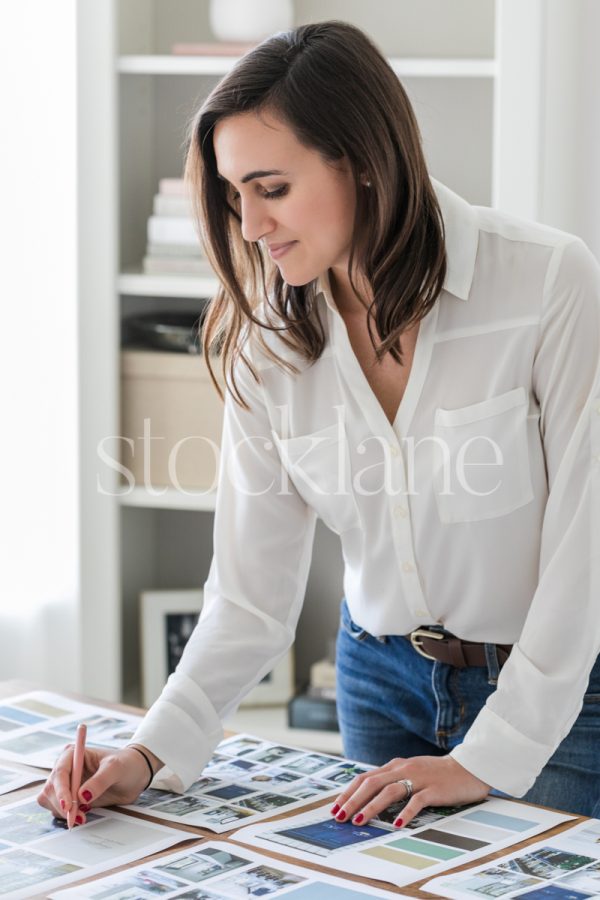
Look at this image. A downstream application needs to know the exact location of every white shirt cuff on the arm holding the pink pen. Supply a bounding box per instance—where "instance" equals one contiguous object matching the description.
[131,673,223,793]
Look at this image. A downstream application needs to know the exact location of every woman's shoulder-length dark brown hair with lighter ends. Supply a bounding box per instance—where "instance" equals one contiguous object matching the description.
[185,21,446,405]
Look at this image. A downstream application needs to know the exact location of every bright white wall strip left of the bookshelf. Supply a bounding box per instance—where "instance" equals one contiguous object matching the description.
[0,0,79,688]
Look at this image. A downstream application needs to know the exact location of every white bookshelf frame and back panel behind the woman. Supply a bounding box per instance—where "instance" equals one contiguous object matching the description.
[78,0,543,720]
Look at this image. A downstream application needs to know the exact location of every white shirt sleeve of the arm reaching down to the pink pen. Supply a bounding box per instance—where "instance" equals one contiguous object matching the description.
[135,356,316,790]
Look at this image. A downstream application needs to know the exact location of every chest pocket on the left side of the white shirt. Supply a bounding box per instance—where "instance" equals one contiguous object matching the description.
[274,423,360,534]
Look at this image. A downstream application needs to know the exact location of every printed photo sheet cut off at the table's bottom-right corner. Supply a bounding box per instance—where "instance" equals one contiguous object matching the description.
[422,819,600,900]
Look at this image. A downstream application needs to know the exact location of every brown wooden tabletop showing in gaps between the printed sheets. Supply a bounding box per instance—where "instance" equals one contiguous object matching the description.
[0,681,583,900]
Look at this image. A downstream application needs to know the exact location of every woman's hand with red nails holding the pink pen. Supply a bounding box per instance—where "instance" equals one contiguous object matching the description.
[37,744,160,825]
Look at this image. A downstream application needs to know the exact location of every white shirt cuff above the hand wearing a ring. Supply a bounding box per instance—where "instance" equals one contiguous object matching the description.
[450,706,554,797]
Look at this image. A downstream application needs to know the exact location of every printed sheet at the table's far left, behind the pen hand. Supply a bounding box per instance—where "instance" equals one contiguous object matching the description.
[0,691,141,769]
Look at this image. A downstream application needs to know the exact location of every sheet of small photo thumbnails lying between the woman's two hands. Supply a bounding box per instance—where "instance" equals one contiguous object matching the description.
[126,734,371,834]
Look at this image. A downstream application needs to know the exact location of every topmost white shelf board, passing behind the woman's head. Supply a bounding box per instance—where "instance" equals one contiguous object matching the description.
[117,55,497,78]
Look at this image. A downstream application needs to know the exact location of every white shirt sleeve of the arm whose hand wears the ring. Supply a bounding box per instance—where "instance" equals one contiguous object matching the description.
[451,239,600,796]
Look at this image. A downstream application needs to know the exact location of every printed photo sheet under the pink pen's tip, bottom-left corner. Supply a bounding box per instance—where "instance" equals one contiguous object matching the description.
[0,798,190,900]
